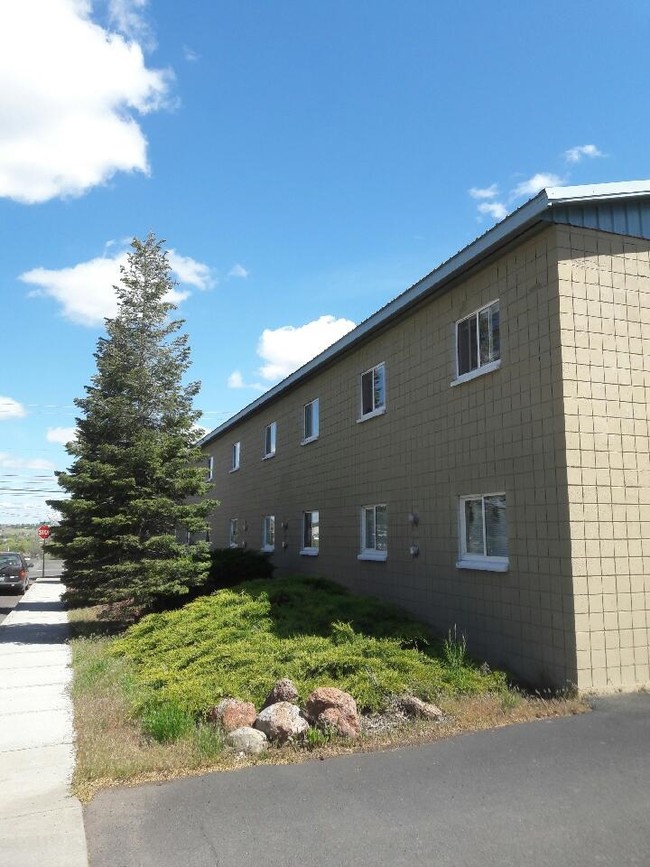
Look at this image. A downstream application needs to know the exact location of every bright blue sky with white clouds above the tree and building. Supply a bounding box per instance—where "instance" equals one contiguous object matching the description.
[0,0,650,523]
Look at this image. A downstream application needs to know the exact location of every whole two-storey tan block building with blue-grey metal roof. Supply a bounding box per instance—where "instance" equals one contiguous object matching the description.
[202,181,650,691]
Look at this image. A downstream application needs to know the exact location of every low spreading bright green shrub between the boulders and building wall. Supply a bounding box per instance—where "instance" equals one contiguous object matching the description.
[113,576,506,718]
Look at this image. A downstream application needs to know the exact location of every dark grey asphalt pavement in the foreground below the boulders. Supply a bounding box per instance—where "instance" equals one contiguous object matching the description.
[84,694,650,867]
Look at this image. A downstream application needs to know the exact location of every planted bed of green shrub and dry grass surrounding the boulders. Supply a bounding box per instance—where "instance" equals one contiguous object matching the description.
[70,576,584,800]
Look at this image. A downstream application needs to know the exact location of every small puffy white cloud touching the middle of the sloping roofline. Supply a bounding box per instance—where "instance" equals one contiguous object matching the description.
[257,316,355,382]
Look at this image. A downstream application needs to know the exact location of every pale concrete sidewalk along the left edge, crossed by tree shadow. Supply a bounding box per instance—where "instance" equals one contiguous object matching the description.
[0,577,88,867]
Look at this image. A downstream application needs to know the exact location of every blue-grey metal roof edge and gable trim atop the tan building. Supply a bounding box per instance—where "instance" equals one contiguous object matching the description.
[199,180,650,445]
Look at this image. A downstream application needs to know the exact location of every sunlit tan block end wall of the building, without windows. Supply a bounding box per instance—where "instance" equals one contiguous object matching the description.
[558,227,650,690]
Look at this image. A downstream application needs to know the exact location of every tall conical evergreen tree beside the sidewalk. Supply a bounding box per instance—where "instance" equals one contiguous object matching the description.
[48,234,215,606]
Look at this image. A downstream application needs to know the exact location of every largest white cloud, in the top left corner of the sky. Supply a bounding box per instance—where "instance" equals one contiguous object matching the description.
[0,0,172,204]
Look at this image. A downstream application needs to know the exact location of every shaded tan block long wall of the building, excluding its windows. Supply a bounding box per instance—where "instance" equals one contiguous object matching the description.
[208,226,577,686]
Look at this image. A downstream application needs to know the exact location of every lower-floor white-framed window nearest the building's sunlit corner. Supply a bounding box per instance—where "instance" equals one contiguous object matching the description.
[457,494,508,571]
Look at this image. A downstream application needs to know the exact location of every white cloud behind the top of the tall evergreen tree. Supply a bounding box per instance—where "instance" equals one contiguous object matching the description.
[19,245,213,326]
